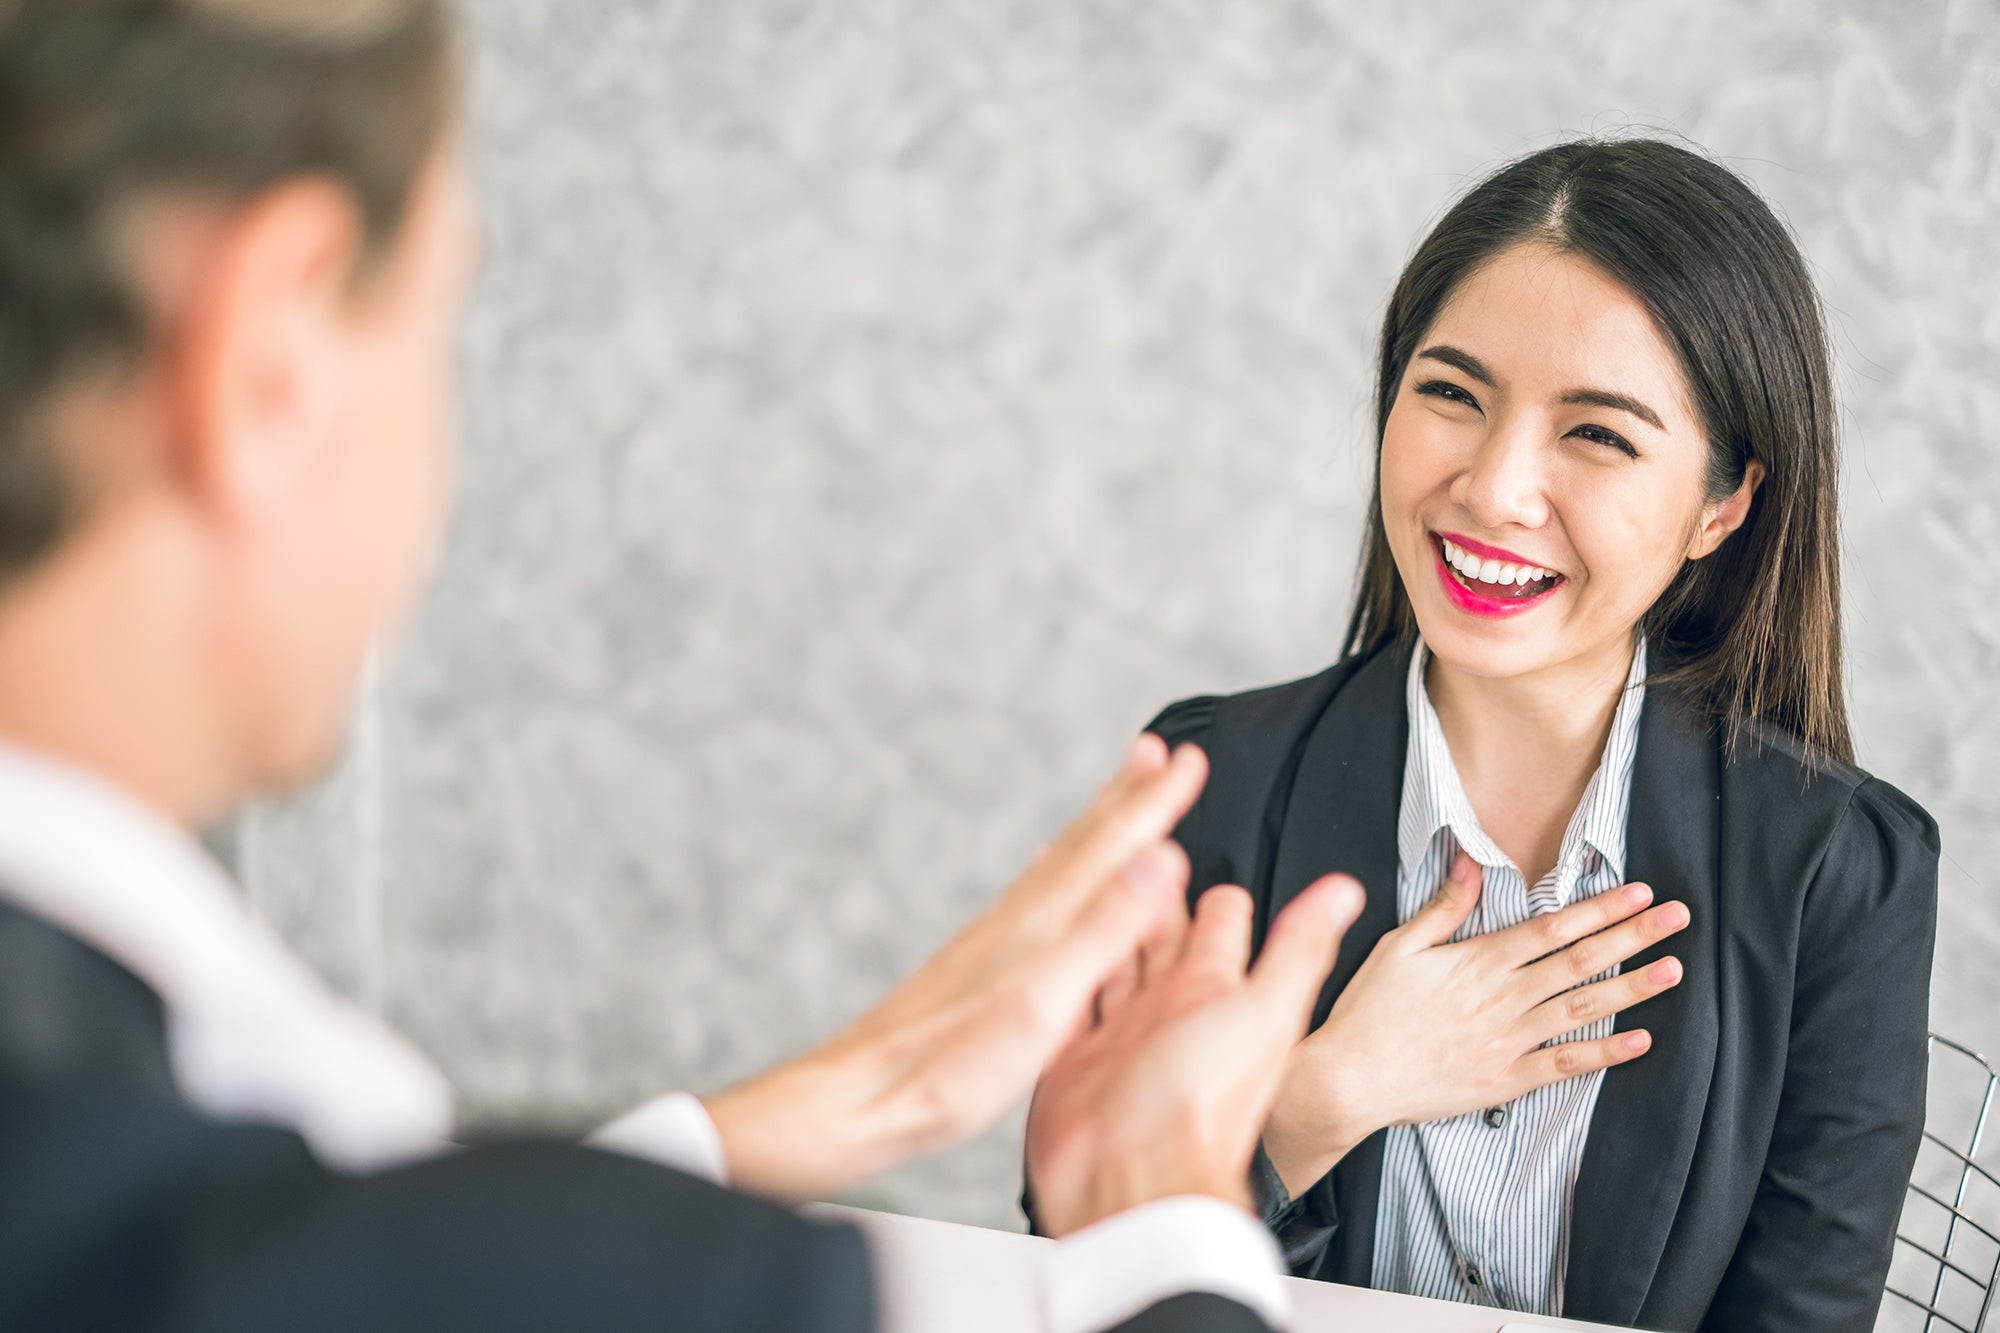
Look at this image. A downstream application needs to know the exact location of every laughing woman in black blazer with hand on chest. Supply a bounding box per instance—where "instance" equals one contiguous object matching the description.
[1152,140,1938,1333]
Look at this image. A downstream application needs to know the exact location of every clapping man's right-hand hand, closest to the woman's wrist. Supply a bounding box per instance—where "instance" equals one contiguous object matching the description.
[1028,875,1362,1237]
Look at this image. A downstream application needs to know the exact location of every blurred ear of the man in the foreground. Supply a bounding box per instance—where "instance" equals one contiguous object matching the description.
[170,180,362,522]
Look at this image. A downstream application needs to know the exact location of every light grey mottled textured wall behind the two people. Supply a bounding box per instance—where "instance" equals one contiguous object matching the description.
[238,0,2000,1223]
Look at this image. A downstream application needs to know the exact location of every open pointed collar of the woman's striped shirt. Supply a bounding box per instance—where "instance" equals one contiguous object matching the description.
[1396,638,1646,881]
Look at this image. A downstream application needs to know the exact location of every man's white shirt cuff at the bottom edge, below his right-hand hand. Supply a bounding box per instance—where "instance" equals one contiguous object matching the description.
[1042,1195,1292,1333]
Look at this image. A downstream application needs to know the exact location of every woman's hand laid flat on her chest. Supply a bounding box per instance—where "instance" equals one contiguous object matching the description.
[1264,853,1688,1197]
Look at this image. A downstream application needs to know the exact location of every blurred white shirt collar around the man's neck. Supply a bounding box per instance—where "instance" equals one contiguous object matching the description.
[0,745,452,1169]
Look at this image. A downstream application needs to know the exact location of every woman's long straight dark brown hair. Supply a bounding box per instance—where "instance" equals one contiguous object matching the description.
[1346,138,1854,761]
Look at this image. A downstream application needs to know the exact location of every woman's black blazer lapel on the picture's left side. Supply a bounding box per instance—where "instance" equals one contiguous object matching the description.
[1258,648,1410,1287]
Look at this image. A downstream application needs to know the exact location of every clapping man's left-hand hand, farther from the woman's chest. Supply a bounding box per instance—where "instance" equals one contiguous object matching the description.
[708,735,1208,1199]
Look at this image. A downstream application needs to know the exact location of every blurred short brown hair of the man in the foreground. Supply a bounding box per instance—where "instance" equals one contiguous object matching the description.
[0,0,458,580]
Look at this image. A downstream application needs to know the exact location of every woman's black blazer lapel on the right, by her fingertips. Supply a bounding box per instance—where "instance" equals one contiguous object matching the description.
[1562,691,1720,1325]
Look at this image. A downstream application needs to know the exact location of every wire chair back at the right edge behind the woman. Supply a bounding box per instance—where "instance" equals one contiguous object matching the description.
[1876,1033,2000,1333]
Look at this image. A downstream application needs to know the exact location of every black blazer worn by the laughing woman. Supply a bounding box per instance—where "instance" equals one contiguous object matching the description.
[1150,648,1938,1333]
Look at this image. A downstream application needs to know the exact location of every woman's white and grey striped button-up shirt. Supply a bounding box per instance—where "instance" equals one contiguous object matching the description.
[1372,642,1646,1315]
